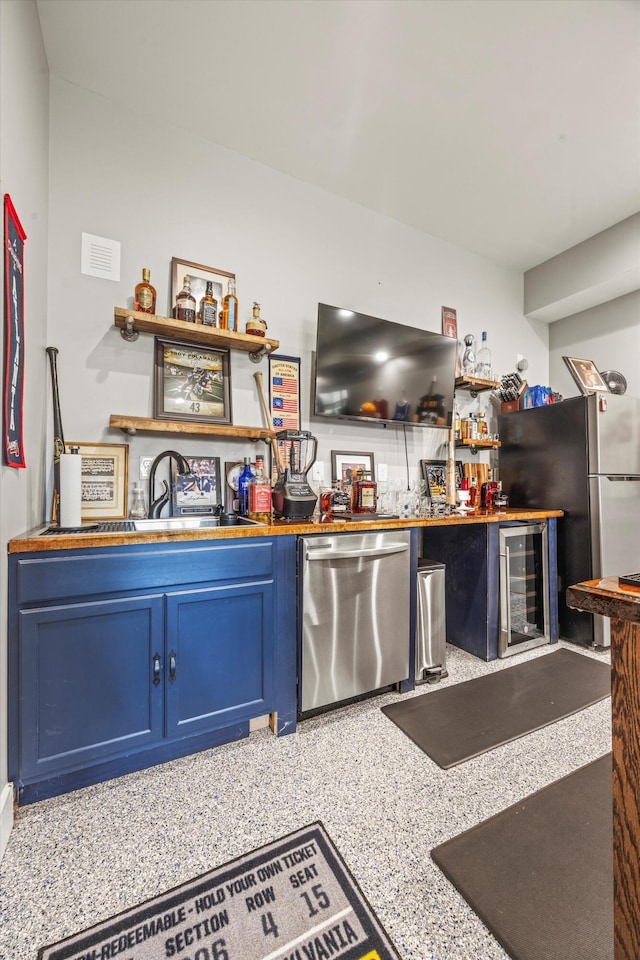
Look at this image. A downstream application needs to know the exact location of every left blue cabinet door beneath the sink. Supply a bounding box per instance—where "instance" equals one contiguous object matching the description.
[19,596,165,779]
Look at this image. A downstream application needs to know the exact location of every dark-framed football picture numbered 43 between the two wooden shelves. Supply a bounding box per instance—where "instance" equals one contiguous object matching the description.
[155,337,231,423]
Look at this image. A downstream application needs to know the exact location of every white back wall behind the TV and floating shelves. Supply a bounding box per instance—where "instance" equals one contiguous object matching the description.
[49,78,548,502]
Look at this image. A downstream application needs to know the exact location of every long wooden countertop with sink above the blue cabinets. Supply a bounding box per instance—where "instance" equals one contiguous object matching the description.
[7,508,563,553]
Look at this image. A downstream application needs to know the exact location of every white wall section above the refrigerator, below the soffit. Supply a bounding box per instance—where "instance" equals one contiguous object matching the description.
[549,290,640,397]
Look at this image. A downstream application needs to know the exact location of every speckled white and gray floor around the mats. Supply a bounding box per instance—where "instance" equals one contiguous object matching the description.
[0,644,611,960]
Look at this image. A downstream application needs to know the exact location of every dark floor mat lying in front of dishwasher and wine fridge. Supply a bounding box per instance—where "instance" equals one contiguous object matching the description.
[382,649,611,769]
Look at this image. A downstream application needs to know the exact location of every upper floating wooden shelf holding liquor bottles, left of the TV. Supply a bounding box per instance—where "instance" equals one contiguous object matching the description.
[114,307,280,359]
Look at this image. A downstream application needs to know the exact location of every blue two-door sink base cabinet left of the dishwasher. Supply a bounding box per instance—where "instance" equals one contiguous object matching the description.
[9,537,296,803]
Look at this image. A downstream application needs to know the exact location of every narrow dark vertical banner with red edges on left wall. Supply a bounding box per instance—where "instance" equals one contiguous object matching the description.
[3,193,27,467]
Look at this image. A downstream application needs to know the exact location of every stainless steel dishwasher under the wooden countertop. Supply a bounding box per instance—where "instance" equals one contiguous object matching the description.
[300,530,411,713]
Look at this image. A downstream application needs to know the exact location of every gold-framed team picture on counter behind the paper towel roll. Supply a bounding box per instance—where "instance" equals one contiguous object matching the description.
[65,441,129,520]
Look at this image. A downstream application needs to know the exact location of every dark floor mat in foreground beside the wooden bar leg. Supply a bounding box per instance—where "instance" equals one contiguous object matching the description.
[431,754,614,960]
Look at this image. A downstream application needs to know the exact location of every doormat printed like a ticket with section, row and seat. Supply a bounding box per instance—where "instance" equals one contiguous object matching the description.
[38,821,400,960]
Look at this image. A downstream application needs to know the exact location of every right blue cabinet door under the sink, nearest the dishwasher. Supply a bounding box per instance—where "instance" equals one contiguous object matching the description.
[165,580,275,737]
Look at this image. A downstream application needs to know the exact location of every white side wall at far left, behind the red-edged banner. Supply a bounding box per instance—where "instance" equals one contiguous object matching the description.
[0,0,49,856]
